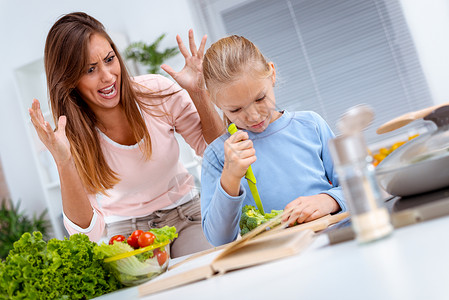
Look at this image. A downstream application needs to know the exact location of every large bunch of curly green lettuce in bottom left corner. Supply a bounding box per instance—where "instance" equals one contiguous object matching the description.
[0,232,122,299]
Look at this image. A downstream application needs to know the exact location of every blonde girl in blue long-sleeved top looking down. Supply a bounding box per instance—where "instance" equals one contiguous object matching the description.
[201,35,346,245]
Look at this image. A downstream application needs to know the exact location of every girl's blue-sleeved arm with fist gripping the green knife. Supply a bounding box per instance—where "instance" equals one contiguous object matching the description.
[201,131,256,246]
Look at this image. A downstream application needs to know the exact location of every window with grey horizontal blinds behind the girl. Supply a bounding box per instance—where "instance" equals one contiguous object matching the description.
[195,0,433,143]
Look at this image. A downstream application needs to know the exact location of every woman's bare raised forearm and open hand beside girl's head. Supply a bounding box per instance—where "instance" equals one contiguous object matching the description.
[161,29,225,144]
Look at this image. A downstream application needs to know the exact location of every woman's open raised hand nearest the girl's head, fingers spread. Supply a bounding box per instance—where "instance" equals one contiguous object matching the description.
[161,29,207,93]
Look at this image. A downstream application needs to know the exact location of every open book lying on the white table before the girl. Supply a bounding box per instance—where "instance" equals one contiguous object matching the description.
[138,213,348,297]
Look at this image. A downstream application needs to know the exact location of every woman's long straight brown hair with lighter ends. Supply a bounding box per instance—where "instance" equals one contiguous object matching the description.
[44,12,177,193]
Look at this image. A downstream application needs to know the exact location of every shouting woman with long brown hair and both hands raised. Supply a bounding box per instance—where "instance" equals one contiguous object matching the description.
[29,12,223,257]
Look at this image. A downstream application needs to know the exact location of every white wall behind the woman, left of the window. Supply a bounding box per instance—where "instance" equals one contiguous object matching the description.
[0,0,204,217]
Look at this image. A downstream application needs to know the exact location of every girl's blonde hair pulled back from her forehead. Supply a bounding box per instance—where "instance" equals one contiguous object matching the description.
[203,35,273,125]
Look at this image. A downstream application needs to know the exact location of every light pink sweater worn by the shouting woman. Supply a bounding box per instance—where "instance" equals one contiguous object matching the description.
[64,75,206,241]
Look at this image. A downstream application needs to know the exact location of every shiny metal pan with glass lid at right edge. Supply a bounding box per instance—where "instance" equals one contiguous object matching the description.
[376,106,449,196]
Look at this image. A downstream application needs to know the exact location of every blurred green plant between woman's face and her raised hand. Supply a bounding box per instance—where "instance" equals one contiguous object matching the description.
[125,33,179,74]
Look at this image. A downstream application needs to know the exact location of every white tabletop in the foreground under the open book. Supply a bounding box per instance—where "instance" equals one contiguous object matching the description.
[98,217,449,300]
